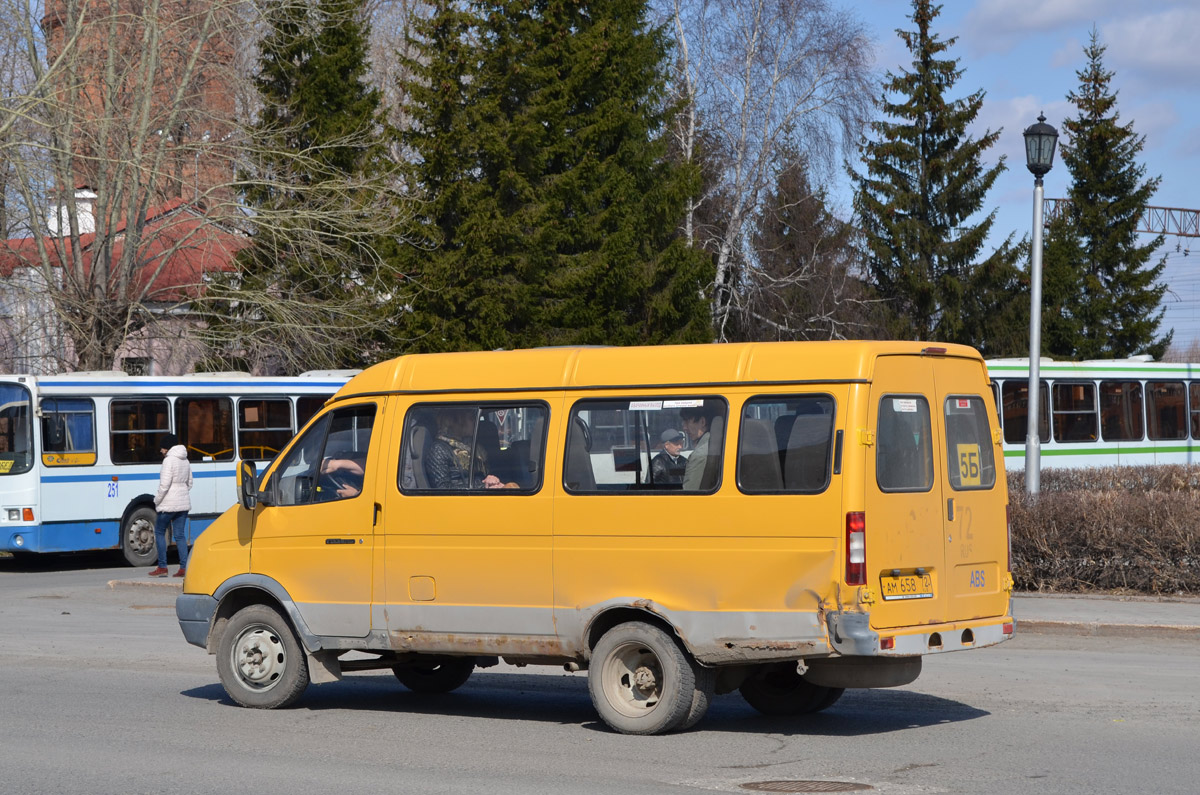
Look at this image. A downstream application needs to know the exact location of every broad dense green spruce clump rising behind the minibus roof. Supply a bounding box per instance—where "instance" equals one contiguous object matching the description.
[398,0,712,351]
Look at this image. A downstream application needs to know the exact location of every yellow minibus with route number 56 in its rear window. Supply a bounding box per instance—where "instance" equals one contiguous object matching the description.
[176,341,1014,734]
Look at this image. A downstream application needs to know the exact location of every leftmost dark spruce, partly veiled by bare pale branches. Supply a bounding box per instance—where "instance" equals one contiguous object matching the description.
[206,0,394,371]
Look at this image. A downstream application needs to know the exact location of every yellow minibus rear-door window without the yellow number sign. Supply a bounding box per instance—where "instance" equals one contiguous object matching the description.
[875,395,934,491]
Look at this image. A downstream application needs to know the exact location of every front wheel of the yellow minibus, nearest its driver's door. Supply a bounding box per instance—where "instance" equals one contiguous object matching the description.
[217,604,308,710]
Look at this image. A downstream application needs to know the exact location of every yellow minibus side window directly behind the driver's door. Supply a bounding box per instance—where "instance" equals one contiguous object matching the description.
[400,404,548,494]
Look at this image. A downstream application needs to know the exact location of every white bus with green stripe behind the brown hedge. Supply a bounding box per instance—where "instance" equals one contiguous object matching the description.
[988,357,1200,470]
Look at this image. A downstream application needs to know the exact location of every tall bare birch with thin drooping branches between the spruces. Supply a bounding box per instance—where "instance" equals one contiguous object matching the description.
[670,0,871,341]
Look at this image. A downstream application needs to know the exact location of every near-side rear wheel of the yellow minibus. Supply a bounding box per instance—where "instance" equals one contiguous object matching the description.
[588,621,700,734]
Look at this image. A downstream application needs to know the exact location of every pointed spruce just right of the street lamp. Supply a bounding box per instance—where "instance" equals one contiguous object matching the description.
[1043,29,1171,359]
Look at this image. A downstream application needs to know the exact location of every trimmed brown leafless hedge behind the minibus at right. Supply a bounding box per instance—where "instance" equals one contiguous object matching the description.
[1008,466,1200,594]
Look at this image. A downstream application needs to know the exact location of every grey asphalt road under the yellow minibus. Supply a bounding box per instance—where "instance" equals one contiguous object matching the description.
[0,557,1200,795]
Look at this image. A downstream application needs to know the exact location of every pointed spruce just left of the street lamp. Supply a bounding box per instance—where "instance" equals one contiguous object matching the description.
[851,0,1027,354]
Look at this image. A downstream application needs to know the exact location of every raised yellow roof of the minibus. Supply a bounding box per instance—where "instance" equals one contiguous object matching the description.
[334,341,986,400]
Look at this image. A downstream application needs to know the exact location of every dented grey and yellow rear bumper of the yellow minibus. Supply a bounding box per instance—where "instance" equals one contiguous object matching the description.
[826,612,1015,657]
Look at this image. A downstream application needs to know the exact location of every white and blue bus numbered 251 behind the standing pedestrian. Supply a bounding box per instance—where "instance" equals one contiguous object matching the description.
[0,370,358,566]
